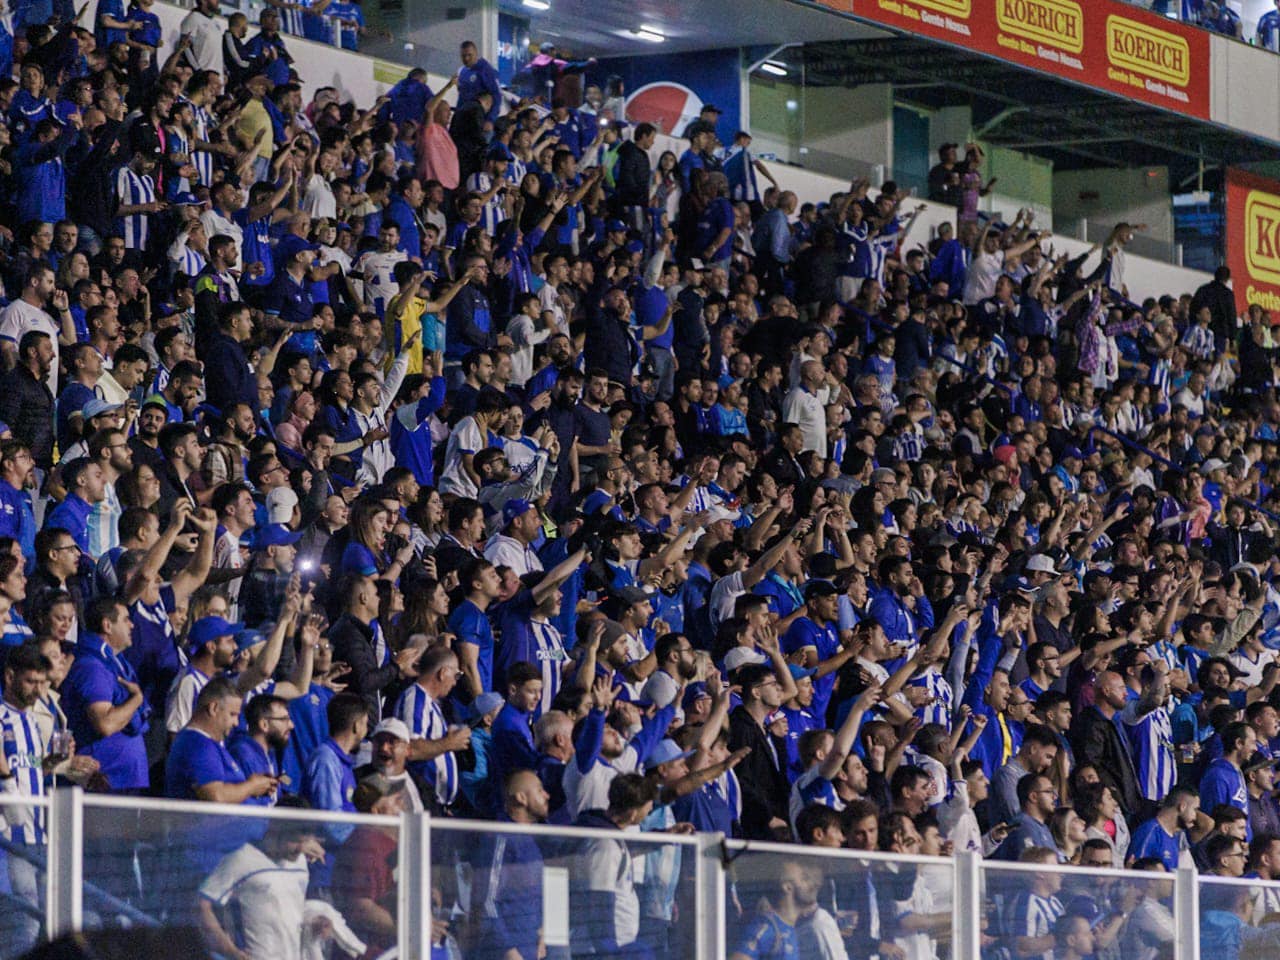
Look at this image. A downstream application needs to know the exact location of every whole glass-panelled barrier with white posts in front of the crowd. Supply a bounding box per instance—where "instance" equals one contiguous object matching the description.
[0,788,1239,960]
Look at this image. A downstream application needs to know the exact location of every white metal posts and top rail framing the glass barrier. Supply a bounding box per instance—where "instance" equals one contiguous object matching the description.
[0,788,1264,960]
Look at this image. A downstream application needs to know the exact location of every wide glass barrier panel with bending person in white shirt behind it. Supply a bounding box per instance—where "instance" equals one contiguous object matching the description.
[83,797,399,960]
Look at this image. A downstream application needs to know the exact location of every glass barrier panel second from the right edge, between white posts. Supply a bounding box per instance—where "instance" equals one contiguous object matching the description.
[980,851,1177,960]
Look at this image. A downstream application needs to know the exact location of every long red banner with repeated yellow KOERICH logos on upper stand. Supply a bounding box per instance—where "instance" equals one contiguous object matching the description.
[818,0,1210,119]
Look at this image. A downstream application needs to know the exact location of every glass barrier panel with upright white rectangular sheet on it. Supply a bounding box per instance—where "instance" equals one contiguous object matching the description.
[431,819,698,960]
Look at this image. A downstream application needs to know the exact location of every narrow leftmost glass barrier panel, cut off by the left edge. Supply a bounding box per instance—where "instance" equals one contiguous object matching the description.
[0,796,49,960]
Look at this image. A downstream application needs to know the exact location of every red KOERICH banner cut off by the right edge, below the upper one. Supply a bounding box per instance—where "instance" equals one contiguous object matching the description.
[1226,169,1280,315]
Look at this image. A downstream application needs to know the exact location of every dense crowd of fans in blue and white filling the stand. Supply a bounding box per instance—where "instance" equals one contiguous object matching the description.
[0,0,1280,960]
